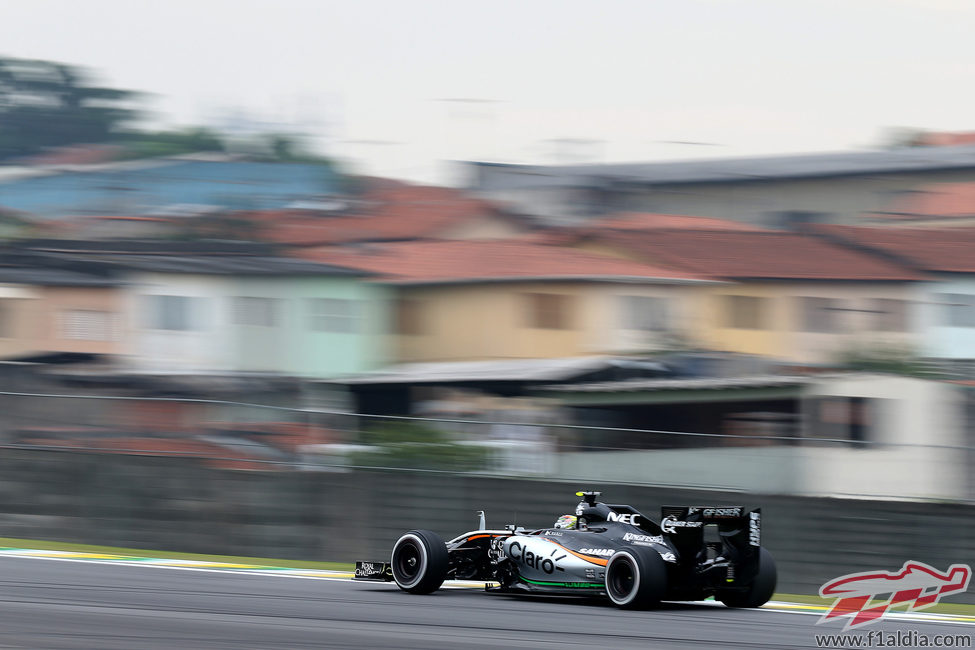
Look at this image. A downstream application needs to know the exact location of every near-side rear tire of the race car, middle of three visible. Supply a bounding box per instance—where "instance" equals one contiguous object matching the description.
[605,547,667,609]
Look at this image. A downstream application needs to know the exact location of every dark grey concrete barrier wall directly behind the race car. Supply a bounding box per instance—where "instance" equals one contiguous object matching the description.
[0,449,975,602]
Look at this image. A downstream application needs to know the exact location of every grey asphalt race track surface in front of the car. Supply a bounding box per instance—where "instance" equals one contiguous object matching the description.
[0,557,975,650]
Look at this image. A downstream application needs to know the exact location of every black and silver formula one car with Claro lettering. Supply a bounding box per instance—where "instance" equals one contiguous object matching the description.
[354,492,776,609]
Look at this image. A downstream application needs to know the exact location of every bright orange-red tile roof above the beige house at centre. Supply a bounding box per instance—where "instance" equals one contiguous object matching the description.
[296,235,710,284]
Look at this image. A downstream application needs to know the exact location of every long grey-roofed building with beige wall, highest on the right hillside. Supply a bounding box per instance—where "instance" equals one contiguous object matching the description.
[468,143,975,228]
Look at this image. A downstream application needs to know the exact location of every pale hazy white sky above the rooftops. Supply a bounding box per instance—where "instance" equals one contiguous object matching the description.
[0,0,975,181]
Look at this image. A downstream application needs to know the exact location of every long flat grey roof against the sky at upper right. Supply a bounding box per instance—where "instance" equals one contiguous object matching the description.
[469,145,975,191]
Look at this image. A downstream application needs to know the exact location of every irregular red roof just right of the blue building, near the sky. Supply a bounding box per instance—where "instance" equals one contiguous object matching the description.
[251,183,513,246]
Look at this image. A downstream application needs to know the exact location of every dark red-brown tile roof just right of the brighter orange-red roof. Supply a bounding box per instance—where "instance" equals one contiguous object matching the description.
[584,230,923,281]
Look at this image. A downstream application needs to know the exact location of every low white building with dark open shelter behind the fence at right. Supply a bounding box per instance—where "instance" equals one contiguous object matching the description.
[536,374,975,500]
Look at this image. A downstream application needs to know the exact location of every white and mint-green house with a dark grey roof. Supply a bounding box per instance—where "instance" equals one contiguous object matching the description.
[4,240,388,377]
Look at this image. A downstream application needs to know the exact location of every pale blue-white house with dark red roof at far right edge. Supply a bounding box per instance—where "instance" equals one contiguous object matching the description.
[814,226,975,368]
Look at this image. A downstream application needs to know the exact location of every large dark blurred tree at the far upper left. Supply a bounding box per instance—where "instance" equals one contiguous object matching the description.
[0,58,138,160]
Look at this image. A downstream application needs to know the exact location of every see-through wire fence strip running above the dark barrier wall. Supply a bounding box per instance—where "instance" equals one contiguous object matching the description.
[0,384,975,503]
